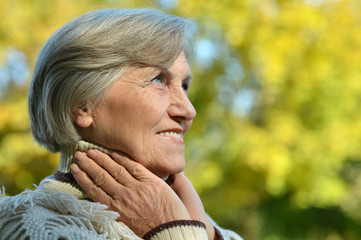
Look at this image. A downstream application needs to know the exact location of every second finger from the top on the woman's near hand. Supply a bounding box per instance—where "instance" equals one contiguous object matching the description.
[87,149,135,186]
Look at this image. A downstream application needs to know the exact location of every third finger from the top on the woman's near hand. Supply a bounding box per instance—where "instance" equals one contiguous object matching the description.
[75,152,123,198]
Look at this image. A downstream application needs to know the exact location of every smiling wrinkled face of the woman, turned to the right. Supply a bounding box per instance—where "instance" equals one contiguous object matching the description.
[83,53,196,177]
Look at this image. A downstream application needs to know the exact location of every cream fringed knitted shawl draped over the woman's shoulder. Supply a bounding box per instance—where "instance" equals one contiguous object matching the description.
[0,190,137,240]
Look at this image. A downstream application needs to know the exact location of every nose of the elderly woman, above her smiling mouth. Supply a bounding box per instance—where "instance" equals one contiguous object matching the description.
[168,89,197,121]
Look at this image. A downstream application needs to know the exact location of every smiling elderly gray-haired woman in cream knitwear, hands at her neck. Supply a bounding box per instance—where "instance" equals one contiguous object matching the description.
[0,9,241,240]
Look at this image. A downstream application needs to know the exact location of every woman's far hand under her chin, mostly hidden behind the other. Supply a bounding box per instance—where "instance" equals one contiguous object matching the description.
[170,172,216,240]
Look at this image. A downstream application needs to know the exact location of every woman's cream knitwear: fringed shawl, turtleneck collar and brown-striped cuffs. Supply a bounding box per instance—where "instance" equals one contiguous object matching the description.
[0,141,241,240]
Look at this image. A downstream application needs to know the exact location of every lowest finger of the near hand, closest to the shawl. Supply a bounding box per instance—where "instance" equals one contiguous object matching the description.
[71,163,110,205]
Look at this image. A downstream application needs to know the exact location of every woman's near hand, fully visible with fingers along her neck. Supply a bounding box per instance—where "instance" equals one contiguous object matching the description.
[72,150,191,237]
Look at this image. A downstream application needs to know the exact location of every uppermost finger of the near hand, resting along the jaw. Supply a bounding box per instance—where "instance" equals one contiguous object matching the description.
[111,152,152,181]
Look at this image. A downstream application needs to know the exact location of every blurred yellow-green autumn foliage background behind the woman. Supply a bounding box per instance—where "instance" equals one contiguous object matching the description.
[0,0,361,240]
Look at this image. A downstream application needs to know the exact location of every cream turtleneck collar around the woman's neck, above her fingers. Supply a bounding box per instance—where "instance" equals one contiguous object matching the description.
[58,140,112,173]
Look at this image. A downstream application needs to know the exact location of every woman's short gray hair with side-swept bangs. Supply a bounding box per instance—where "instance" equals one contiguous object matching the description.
[28,9,194,152]
